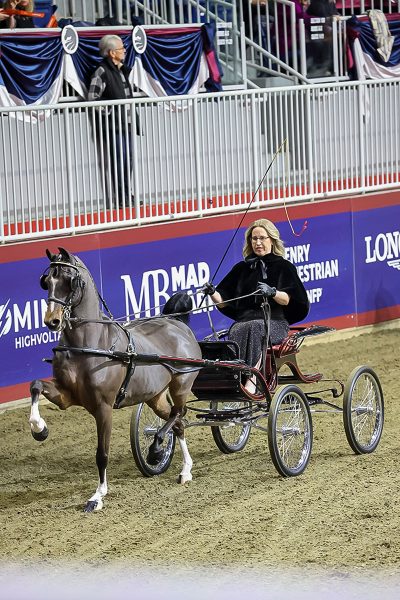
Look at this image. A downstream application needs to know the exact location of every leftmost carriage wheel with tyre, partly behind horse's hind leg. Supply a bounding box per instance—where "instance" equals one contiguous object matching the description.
[130,403,176,477]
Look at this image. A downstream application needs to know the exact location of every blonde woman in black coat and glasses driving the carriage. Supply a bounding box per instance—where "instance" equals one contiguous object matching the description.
[203,219,309,393]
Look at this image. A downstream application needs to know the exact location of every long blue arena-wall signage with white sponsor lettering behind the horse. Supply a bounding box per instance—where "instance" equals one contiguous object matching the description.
[0,206,400,394]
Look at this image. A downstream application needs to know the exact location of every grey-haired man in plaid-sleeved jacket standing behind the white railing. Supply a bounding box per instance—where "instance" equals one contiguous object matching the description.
[88,35,133,207]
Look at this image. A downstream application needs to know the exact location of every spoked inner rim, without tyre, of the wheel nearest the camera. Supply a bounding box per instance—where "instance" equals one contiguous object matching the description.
[275,393,312,472]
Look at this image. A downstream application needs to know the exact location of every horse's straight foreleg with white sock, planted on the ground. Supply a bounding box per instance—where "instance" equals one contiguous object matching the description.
[84,402,112,512]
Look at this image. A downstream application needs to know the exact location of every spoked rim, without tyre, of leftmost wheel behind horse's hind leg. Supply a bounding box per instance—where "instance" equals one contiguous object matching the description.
[137,404,174,472]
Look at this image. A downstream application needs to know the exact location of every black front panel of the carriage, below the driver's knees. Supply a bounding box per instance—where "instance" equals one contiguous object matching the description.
[192,340,244,400]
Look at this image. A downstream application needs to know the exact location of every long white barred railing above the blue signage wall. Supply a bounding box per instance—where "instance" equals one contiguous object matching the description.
[0,80,400,243]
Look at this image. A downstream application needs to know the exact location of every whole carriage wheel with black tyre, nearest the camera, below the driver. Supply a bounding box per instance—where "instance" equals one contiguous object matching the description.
[268,385,313,477]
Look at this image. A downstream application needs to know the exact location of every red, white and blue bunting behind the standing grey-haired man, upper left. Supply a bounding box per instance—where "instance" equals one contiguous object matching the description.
[0,24,222,106]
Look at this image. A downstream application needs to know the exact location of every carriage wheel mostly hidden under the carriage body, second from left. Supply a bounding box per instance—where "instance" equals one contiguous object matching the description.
[210,400,250,454]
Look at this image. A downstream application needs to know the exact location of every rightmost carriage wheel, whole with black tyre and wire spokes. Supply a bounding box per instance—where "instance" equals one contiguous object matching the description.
[343,366,384,454]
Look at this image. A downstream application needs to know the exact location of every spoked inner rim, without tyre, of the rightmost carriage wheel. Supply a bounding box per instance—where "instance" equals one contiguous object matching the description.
[351,373,383,448]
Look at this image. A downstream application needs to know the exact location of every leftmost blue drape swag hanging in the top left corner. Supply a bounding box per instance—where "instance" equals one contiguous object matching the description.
[0,34,64,104]
